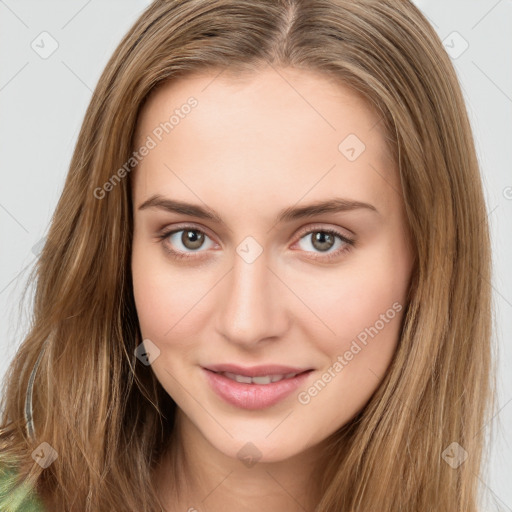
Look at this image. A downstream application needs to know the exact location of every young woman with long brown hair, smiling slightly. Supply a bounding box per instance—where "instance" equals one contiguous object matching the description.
[0,0,492,512]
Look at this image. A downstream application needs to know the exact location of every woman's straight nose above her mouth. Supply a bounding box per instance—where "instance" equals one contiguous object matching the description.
[217,247,290,349]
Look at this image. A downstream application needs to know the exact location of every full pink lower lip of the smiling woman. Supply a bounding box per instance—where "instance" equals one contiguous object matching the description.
[202,368,312,410]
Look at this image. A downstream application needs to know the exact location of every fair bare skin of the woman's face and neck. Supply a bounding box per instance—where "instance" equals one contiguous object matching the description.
[132,67,413,512]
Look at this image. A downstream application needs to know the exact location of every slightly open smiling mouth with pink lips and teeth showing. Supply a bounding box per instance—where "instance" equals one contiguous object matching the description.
[201,367,314,410]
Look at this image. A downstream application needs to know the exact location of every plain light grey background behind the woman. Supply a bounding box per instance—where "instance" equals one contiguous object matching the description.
[0,0,512,512]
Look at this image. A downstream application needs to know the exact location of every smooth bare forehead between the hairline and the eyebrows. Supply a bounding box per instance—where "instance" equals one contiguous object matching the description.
[134,67,400,218]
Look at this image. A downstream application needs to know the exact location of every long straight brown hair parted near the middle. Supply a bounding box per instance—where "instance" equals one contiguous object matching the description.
[0,0,494,512]
